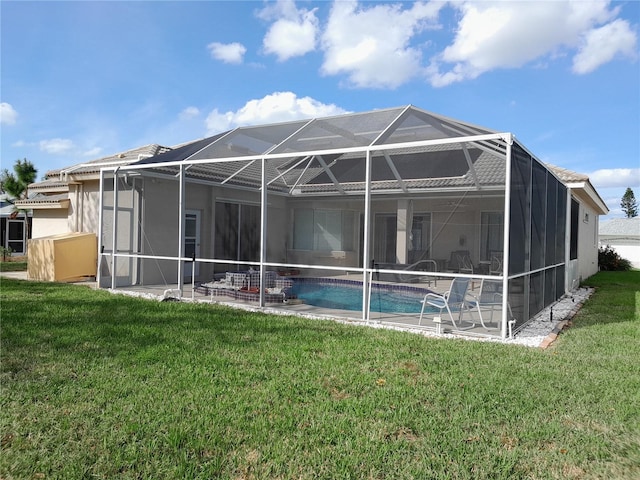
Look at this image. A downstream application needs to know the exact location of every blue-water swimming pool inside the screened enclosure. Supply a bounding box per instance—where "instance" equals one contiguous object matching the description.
[291,278,430,314]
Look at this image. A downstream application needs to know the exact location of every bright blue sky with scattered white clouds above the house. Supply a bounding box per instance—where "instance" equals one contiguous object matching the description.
[0,0,640,218]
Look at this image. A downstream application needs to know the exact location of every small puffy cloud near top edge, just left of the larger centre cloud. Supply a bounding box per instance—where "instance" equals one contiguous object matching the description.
[258,0,319,61]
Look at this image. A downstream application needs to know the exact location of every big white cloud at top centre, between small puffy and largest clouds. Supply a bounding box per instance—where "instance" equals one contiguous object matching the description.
[322,0,444,88]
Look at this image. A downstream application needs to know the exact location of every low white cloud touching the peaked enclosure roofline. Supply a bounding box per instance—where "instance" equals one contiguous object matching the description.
[206,92,347,135]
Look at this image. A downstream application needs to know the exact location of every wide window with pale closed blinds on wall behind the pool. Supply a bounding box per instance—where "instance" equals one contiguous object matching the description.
[293,208,355,251]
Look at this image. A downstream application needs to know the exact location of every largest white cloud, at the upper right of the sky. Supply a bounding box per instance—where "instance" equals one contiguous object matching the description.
[428,0,637,86]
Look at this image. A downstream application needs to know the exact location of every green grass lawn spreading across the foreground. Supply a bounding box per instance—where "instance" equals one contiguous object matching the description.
[0,271,640,479]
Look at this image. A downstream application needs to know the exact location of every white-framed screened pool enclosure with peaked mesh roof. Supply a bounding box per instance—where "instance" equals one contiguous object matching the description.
[99,106,572,337]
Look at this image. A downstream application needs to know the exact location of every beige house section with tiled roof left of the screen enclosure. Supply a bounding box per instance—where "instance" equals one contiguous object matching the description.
[15,145,169,238]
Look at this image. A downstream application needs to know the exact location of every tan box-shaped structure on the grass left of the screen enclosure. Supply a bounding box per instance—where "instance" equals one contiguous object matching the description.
[27,233,98,282]
